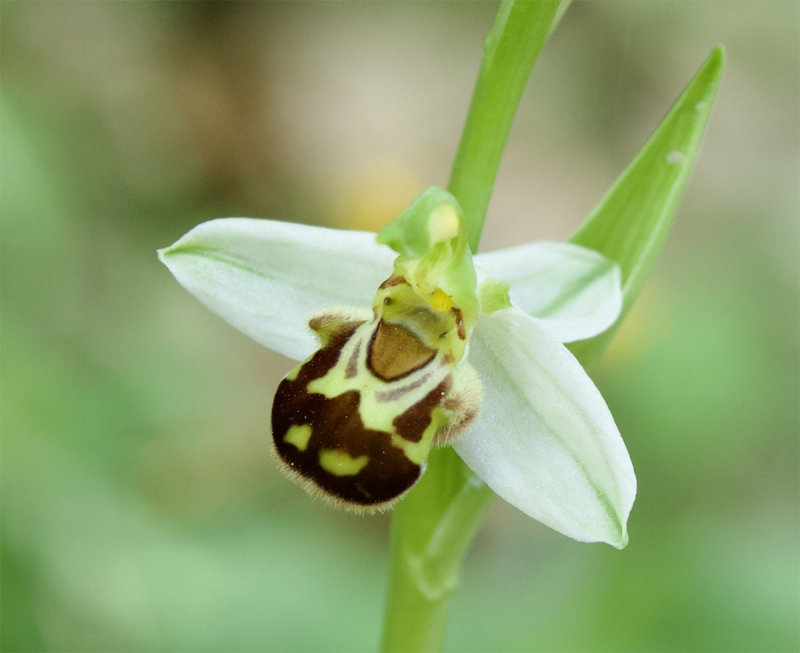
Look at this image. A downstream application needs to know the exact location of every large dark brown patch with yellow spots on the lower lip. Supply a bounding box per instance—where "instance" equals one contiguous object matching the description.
[272,330,421,506]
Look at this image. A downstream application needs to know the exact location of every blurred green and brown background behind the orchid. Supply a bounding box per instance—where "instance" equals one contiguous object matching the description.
[2,1,800,652]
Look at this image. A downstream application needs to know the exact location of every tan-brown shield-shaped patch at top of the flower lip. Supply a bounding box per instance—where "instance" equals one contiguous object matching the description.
[367,320,436,381]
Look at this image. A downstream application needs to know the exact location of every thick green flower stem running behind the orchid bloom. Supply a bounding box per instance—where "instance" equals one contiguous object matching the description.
[381,0,568,653]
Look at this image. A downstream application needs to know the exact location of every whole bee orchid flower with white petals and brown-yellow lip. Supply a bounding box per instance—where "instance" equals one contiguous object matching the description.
[159,188,636,548]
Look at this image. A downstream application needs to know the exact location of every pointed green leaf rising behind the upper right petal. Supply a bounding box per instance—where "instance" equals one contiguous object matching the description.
[570,45,725,365]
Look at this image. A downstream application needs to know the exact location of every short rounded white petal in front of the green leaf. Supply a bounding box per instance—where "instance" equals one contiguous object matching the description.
[475,242,622,342]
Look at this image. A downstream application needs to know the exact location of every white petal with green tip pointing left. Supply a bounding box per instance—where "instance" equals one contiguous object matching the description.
[159,218,394,360]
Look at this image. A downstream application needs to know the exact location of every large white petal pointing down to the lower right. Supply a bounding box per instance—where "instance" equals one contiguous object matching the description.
[453,307,636,548]
